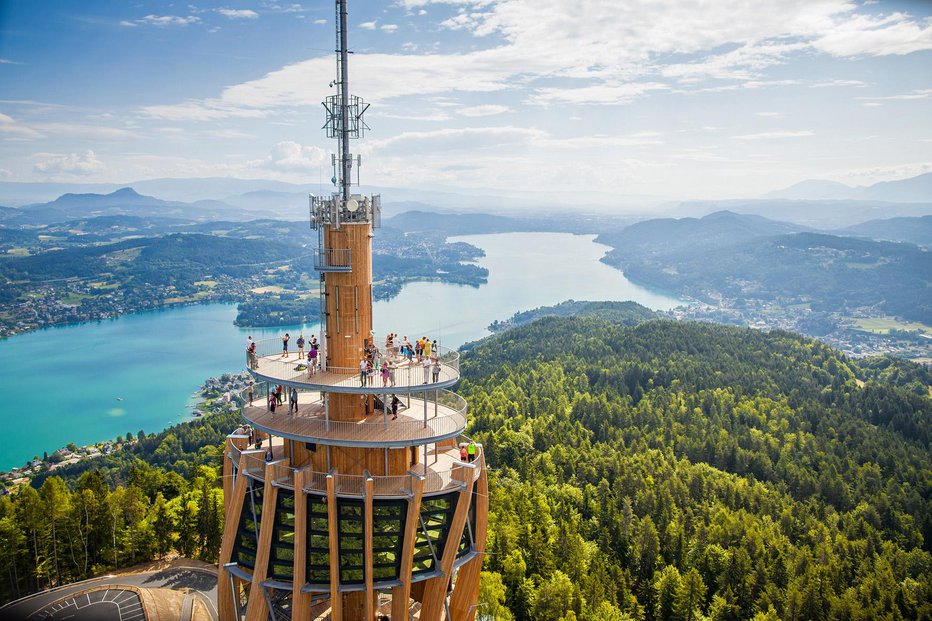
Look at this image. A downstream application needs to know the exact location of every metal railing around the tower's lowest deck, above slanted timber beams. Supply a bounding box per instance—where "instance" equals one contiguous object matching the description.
[237,445,482,498]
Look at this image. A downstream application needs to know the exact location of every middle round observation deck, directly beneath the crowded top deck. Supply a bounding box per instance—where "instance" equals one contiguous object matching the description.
[243,390,466,448]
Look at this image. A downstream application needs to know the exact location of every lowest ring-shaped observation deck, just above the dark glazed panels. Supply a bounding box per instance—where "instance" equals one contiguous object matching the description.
[227,436,482,499]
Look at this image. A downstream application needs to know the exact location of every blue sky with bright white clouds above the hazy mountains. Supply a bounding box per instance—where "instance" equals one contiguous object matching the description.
[0,0,932,199]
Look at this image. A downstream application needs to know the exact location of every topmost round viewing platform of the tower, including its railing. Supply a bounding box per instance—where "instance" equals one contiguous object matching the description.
[246,339,460,395]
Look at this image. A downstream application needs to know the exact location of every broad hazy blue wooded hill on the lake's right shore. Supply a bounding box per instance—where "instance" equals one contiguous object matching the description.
[599,214,932,324]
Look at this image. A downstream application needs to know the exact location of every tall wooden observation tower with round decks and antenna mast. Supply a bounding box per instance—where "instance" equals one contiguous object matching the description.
[217,0,488,621]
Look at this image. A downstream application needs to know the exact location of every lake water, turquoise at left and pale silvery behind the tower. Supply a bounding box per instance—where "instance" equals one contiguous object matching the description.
[0,233,679,470]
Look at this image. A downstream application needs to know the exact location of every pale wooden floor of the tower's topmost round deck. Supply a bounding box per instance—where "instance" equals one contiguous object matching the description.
[251,353,459,393]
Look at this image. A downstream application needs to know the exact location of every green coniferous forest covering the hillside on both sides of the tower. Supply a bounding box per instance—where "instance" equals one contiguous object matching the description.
[0,317,932,621]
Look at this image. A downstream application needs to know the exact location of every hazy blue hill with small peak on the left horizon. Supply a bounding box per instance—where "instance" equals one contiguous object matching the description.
[11,188,255,224]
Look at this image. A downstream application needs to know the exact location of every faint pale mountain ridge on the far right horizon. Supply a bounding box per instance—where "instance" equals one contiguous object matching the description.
[763,173,932,203]
